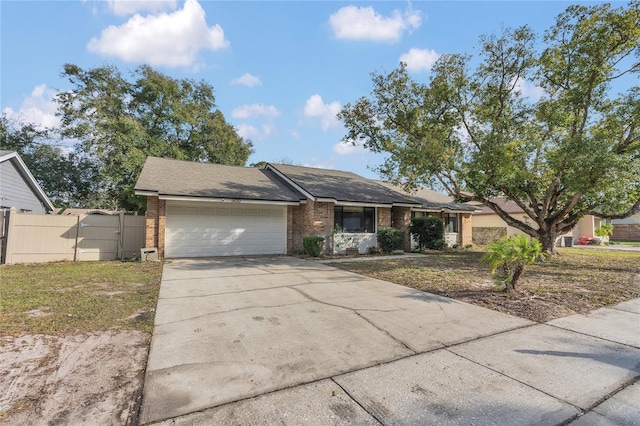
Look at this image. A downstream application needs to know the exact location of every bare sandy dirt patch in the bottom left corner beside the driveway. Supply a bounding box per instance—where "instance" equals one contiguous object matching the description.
[0,331,149,425]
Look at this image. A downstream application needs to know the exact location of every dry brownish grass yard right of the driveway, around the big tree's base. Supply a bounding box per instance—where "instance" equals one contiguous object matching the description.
[332,248,640,322]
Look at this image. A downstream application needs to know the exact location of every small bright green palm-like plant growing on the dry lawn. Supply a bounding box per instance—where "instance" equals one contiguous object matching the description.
[481,234,546,291]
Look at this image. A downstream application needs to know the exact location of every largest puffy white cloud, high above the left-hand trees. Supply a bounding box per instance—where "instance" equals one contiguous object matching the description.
[87,0,229,67]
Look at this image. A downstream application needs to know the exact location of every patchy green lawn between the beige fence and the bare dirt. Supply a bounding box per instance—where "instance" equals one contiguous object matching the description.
[0,261,162,336]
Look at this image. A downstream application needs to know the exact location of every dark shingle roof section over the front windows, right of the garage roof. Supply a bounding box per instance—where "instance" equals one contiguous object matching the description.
[266,164,419,207]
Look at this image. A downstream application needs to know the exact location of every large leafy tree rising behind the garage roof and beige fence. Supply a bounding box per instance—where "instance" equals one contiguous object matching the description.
[56,64,252,211]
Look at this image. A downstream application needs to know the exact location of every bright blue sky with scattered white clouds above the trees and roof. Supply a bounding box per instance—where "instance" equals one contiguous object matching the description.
[0,0,624,178]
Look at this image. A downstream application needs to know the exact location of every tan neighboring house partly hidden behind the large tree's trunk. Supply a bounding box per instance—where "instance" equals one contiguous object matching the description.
[470,200,602,246]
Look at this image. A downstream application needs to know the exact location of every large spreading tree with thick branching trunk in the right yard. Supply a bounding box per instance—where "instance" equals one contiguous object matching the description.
[340,1,640,252]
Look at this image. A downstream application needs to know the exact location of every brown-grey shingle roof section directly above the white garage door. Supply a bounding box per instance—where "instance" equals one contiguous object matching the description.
[134,157,305,204]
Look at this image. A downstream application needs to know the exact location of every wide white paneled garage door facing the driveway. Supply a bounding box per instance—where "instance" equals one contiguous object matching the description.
[165,201,287,257]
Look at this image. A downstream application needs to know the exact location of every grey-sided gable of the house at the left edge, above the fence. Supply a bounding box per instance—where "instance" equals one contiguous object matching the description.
[0,150,53,213]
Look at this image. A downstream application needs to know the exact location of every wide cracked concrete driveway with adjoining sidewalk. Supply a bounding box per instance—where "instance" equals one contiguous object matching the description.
[140,256,640,425]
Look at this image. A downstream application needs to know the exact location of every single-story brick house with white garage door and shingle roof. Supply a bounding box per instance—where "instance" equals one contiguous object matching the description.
[135,157,471,257]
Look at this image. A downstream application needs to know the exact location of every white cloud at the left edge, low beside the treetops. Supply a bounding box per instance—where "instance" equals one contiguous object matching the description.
[2,84,60,130]
